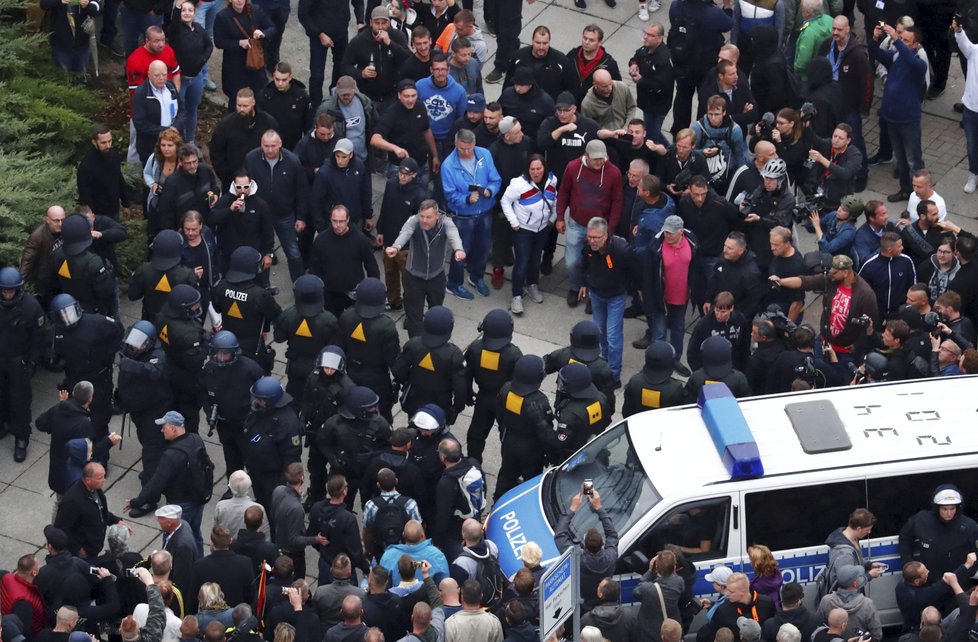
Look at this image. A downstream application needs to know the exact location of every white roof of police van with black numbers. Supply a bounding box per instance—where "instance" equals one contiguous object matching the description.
[628,376,978,496]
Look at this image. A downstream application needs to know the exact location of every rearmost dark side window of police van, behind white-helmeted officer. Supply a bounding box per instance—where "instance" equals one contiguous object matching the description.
[866,468,978,538]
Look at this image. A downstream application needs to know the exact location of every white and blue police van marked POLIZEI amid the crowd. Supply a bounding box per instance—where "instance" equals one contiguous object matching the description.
[486,376,978,627]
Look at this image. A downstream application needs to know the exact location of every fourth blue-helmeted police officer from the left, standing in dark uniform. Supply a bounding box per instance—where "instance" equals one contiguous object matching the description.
[199,330,265,488]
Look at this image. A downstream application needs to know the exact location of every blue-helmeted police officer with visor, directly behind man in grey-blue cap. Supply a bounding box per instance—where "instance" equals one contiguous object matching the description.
[116,321,173,482]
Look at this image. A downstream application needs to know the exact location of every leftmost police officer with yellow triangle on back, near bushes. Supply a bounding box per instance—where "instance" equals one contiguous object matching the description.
[49,214,119,316]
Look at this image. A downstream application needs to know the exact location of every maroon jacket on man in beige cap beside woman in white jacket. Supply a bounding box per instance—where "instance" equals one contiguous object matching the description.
[557,156,622,230]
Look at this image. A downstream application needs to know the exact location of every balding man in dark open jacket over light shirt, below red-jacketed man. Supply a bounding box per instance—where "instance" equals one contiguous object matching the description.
[132,60,186,165]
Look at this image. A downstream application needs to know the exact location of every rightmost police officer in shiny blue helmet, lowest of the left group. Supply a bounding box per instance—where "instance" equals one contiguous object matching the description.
[244,377,302,506]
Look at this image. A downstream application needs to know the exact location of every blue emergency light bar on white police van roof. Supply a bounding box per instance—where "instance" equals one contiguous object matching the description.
[696,383,764,479]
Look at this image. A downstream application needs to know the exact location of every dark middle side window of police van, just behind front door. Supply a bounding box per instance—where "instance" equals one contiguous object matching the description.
[744,480,875,551]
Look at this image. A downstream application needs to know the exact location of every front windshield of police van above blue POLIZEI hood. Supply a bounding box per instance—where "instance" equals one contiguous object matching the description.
[543,421,662,542]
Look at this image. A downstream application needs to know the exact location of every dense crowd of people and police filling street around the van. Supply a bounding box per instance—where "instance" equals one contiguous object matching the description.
[11,0,978,642]
